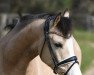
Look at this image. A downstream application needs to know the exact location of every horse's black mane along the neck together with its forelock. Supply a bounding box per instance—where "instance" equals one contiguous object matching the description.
[5,13,72,38]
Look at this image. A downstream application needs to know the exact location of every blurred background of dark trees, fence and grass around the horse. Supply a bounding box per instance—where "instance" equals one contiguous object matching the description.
[0,0,94,75]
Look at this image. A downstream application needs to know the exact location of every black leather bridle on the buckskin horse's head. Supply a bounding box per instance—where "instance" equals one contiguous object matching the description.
[41,16,79,75]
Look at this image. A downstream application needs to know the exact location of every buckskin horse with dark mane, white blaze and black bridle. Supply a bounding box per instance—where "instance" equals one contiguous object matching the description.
[0,11,81,75]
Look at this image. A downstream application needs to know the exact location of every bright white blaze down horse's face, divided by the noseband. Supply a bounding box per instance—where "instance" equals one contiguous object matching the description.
[66,37,82,75]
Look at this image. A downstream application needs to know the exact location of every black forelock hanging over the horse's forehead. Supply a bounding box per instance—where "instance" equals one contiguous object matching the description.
[57,17,72,38]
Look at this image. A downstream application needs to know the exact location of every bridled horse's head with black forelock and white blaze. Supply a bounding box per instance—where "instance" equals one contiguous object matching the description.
[40,11,81,75]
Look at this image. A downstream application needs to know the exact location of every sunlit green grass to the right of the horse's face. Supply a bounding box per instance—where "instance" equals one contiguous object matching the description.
[73,30,94,72]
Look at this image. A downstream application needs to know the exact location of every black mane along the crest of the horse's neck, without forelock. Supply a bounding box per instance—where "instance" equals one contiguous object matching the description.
[3,13,55,31]
